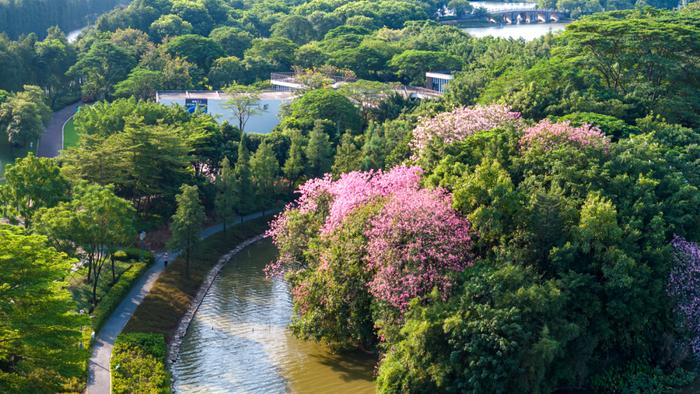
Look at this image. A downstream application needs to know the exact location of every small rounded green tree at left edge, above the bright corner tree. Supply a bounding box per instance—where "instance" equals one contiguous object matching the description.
[0,153,69,227]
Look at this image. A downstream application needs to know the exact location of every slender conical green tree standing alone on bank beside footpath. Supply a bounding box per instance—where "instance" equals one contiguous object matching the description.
[169,185,206,279]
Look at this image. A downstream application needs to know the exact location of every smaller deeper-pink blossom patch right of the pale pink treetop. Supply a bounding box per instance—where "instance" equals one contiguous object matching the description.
[520,119,610,150]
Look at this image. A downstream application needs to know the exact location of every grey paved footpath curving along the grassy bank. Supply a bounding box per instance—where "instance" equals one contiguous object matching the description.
[87,211,272,394]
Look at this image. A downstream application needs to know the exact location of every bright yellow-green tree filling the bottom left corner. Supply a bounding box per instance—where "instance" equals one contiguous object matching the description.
[0,225,90,393]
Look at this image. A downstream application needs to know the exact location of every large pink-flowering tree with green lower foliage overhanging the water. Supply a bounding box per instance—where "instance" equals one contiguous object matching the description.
[266,167,471,347]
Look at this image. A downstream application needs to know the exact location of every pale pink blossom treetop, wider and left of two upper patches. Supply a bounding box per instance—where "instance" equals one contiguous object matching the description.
[411,105,520,153]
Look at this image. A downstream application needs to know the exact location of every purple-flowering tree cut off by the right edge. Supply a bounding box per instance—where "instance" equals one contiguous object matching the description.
[668,237,700,357]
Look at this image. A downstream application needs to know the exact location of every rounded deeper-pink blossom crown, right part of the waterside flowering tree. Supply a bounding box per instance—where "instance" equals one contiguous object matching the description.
[365,189,470,311]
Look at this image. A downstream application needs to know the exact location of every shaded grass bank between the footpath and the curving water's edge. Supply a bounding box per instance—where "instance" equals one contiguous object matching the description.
[124,216,271,340]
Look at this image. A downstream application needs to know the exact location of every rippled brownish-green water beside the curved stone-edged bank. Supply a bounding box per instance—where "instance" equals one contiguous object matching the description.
[172,240,375,394]
